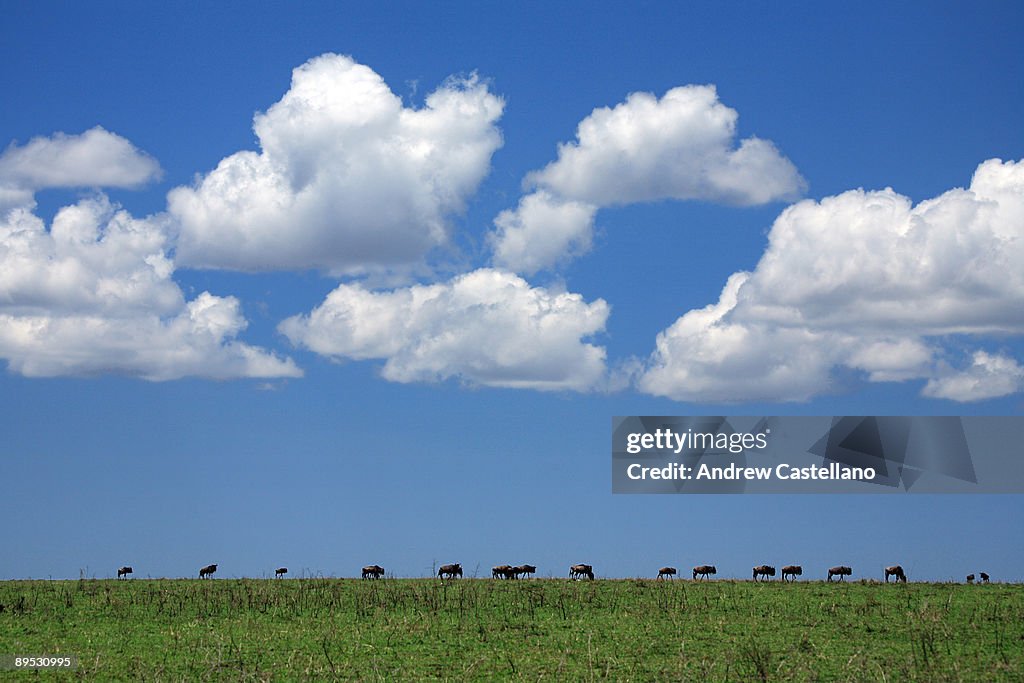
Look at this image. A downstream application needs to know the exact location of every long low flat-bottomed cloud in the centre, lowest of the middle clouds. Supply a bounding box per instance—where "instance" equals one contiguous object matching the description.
[280,268,609,391]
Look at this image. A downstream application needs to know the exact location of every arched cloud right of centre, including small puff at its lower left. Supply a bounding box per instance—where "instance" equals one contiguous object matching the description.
[490,85,806,274]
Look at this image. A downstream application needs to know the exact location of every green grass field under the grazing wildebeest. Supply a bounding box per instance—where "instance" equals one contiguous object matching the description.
[0,579,1024,682]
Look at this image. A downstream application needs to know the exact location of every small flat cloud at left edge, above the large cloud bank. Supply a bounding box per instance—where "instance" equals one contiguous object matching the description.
[0,126,161,209]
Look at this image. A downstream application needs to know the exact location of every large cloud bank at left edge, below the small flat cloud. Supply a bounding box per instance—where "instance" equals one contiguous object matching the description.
[0,196,301,380]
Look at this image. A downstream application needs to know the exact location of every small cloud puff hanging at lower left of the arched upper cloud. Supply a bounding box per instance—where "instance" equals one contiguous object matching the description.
[488,190,597,275]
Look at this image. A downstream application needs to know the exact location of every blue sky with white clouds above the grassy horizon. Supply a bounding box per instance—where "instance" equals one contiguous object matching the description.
[0,2,1024,581]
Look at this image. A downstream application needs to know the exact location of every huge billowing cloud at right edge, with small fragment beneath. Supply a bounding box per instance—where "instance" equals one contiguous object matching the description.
[638,160,1024,401]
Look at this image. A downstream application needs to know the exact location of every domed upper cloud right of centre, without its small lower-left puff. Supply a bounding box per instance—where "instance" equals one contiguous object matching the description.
[527,85,805,206]
